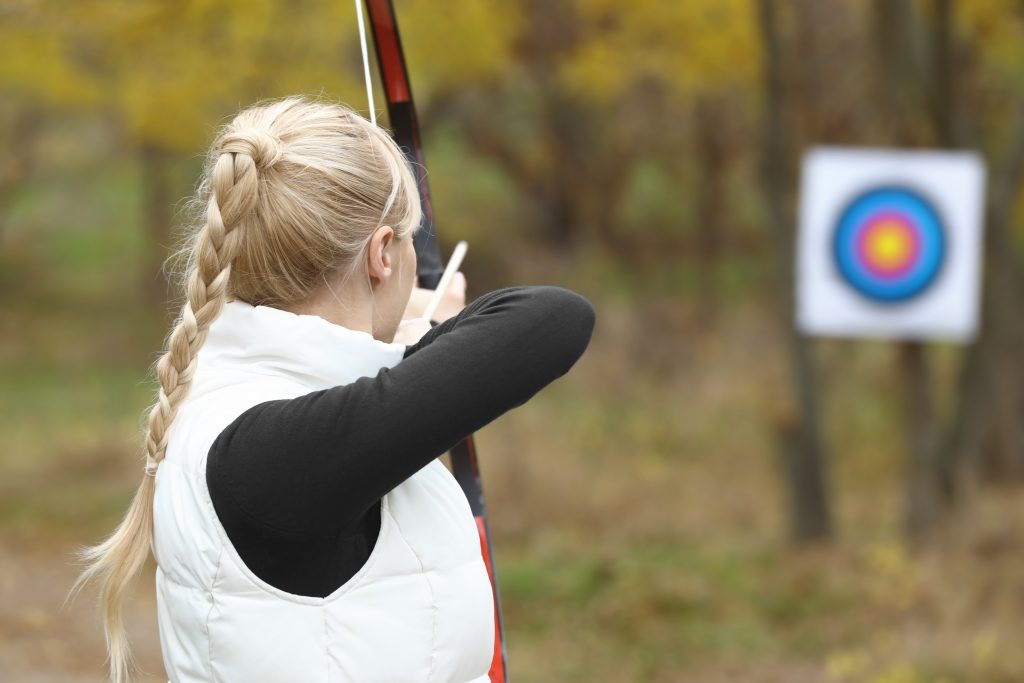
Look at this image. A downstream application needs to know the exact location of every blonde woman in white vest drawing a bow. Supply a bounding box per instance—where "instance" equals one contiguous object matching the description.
[80,97,594,683]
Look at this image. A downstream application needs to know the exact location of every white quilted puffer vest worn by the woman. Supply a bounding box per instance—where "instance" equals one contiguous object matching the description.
[154,301,495,683]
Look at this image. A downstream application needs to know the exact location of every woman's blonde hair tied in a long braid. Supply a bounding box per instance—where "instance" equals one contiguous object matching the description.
[72,96,421,683]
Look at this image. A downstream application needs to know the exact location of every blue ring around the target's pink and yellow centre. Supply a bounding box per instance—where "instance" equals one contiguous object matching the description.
[833,186,947,303]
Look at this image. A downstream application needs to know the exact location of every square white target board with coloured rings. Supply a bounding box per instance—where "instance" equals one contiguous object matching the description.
[796,147,985,342]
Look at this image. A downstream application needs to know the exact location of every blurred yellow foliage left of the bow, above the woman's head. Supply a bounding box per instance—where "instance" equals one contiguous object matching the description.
[0,0,366,152]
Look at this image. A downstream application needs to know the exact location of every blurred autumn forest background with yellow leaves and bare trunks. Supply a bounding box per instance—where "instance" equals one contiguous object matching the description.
[0,0,1024,683]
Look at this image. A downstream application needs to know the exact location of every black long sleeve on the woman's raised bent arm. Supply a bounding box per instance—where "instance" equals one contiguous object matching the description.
[206,287,595,597]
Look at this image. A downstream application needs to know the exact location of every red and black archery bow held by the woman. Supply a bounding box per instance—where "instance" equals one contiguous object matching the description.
[356,0,508,683]
